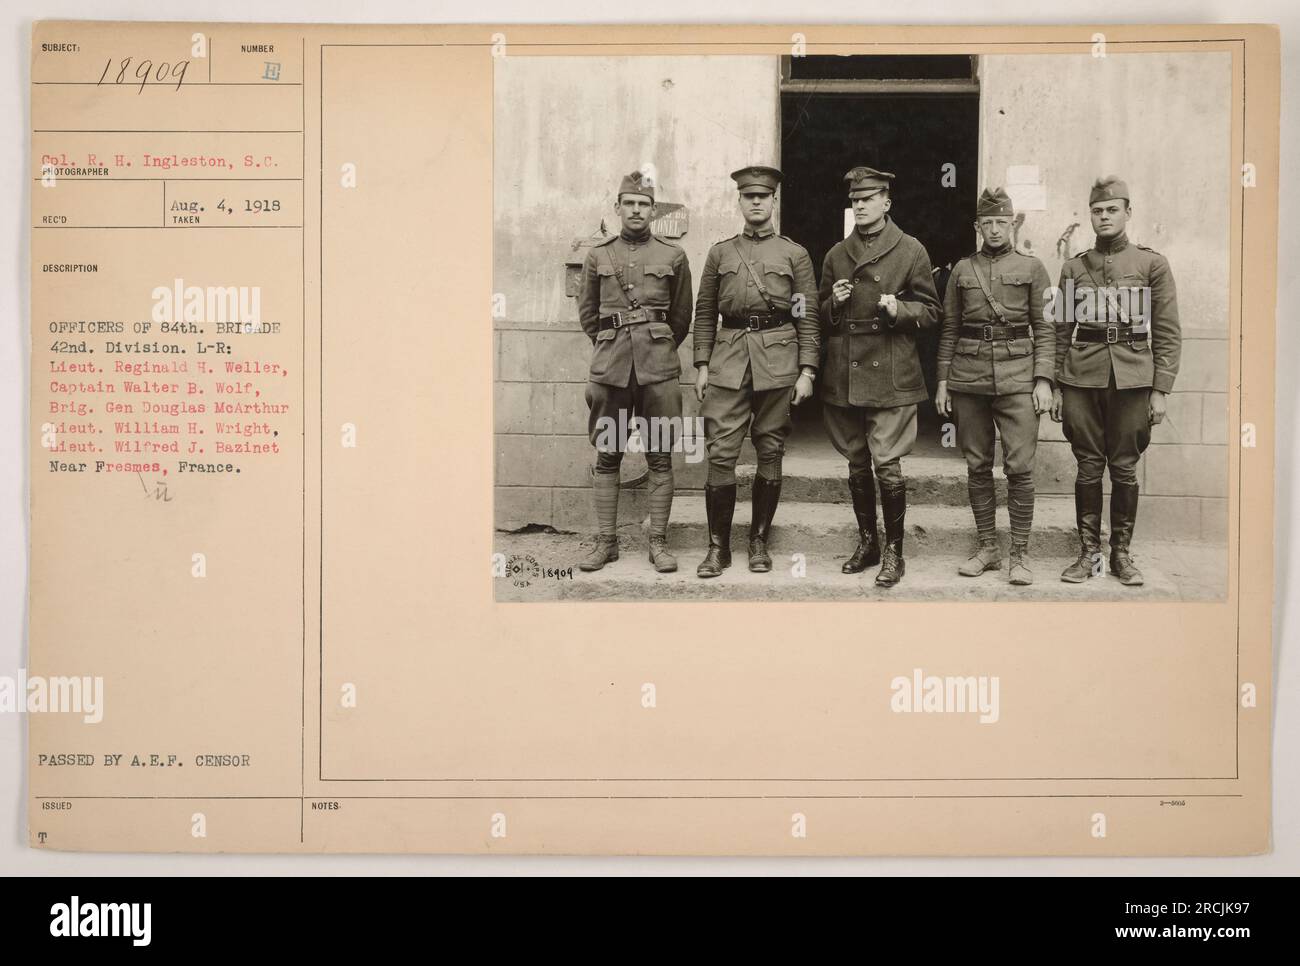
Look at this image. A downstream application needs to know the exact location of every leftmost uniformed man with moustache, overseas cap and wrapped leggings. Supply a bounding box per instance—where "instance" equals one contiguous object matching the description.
[579,172,690,572]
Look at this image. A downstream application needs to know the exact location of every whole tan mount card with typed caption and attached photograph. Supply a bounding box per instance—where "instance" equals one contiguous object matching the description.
[27,21,1279,855]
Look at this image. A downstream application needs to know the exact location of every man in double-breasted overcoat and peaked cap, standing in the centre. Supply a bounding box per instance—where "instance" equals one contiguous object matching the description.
[819,165,939,586]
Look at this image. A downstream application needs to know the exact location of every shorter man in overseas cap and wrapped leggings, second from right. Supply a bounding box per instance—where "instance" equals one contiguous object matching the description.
[935,187,1056,585]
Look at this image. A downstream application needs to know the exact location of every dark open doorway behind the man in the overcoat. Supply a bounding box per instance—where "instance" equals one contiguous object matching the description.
[780,56,979,455]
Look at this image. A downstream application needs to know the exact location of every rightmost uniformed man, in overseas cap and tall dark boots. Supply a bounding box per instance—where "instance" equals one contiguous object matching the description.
[1052,176,1182,586]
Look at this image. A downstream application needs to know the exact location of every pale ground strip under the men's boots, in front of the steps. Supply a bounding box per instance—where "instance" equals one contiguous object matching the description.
[497,534,1190,601]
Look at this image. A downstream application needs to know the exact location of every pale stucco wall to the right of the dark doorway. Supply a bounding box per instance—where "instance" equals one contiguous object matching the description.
[971,52,1232,540]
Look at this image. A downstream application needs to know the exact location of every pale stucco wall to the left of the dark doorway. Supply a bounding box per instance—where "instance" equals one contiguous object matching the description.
[494,56,780,529]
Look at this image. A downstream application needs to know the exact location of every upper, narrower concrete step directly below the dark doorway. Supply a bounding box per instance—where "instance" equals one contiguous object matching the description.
[736,451,1006,507]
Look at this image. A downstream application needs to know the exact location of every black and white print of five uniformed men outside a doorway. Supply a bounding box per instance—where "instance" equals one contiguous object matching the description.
[493,51,1232,601]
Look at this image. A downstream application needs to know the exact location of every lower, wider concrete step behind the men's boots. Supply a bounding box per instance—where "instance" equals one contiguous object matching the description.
[637,494,1081,556]
